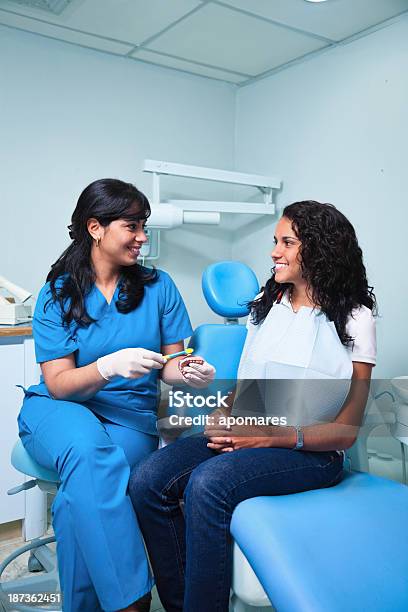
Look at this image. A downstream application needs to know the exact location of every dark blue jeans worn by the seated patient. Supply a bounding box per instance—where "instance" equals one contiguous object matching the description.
[129,436,343,612]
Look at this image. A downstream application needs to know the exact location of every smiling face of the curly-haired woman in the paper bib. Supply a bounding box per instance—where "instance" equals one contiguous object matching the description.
[271,217,303,284]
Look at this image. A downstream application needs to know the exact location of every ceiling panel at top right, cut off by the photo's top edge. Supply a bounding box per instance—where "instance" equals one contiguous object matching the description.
[223,0,408,41]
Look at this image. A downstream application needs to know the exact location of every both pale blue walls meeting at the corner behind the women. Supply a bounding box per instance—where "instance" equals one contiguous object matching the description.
[0,18,408,368]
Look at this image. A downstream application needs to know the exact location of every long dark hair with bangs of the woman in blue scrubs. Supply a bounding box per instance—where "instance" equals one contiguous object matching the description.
[44,179,157,326]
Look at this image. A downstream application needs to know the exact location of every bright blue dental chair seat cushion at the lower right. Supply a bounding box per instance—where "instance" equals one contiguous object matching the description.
[231,472,408,612]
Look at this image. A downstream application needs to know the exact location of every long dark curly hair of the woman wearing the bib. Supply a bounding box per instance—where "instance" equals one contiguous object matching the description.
[249,200,377,346]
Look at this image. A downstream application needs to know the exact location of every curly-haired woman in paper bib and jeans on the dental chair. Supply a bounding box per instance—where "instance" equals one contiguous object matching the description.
[130,201,376,612]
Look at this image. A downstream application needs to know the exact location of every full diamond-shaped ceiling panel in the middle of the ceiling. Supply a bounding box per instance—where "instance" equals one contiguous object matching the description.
[147,4,324,76]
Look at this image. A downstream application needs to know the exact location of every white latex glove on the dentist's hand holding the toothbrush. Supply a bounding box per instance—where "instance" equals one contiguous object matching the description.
[96,348,166,380]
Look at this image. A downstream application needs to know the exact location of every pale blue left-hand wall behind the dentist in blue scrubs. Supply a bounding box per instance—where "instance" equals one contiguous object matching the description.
[0,27,235,324]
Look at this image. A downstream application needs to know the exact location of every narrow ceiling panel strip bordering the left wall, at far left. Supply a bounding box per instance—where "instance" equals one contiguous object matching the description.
[0,10,133,55]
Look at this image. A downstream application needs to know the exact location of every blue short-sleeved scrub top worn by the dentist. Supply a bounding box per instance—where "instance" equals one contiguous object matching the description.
[26,270,193,435]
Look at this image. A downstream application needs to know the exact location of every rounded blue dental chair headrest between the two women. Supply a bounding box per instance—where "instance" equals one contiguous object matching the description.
[202,261,259,318]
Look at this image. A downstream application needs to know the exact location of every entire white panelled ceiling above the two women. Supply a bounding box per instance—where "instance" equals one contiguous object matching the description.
[0,0,408,84]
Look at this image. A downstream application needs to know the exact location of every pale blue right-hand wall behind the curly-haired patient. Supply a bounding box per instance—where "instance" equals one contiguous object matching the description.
[233,18,408,378]
